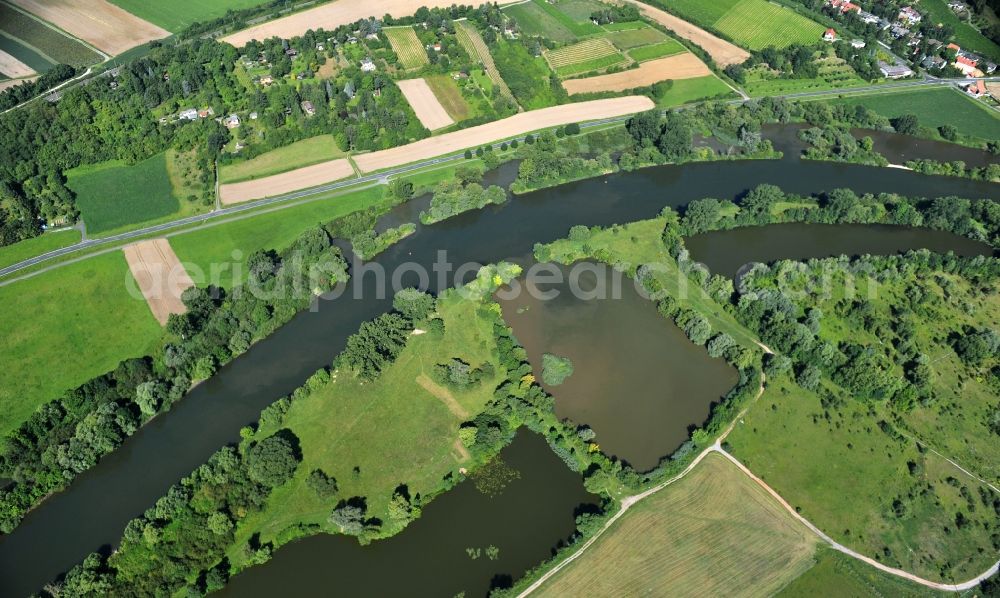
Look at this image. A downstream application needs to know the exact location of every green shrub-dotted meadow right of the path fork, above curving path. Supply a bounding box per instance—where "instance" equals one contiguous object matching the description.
[728,370,995,581]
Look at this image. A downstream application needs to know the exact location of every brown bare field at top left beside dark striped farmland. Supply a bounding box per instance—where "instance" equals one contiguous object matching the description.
[11,0,170,55]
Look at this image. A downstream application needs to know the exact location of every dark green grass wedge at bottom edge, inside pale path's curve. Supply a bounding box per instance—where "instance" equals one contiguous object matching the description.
[777,547,954,598]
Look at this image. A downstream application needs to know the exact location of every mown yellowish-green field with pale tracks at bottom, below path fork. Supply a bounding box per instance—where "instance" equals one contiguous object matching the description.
[538,455,816,596]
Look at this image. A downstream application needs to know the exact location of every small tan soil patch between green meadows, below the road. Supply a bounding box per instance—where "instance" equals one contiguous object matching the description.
[122,239,194,326]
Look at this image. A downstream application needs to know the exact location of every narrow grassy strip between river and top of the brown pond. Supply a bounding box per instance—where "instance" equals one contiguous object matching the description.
[547,218,757,348]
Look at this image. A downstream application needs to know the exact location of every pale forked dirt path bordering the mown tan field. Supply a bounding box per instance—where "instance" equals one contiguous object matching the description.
[518,370,1000,598]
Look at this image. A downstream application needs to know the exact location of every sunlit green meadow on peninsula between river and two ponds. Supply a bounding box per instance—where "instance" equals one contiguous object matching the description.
[231,292,503,559]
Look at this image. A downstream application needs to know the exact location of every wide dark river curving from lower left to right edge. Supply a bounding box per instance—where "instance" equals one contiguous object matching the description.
[0,152,1000,596]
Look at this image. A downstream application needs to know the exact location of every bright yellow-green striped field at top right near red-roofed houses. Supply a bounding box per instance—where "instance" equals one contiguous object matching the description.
[714,0,825,50]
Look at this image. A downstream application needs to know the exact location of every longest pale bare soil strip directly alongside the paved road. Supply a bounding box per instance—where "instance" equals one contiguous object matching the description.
[352,96,655,176]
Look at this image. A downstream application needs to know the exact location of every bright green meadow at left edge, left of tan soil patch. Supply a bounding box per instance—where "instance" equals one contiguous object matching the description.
[0,252,162,434]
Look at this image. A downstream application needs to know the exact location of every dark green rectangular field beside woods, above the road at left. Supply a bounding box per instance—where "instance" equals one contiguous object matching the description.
[66,153,181,233]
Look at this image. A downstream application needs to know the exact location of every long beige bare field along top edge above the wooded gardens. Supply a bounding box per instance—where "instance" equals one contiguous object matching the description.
[222,0,519,48]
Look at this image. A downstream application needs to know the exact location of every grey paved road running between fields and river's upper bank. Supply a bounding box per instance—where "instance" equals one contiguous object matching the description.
[0,76,1000,286]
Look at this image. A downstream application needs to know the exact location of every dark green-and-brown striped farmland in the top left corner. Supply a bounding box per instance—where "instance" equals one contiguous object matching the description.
[0,2,102,67]
